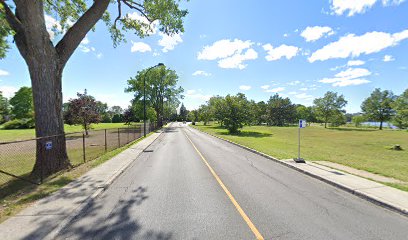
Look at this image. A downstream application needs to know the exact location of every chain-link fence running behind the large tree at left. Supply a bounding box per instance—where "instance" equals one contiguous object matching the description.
[0,123,157,188]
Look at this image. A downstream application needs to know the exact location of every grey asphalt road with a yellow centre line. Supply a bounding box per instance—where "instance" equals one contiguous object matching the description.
[58,123,408,240]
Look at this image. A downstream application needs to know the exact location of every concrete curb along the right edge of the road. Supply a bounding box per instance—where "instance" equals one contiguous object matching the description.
[192,127,408,217]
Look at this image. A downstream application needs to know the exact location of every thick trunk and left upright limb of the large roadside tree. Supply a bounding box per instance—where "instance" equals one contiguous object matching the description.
[10,1,69,177]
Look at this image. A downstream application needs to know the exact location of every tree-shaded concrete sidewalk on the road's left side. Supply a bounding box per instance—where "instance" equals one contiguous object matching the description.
[0,132,161,239]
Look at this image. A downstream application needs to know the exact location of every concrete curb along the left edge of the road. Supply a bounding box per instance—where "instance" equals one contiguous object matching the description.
[44,131,163,240]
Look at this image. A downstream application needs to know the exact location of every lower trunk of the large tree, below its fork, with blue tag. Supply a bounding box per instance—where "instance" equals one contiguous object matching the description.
[29,59,70,176]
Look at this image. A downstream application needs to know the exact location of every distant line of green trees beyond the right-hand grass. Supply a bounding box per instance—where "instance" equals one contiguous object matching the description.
[190,88,408,133]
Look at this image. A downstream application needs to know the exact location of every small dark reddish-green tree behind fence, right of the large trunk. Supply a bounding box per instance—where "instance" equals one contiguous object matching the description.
[64,89,101,135]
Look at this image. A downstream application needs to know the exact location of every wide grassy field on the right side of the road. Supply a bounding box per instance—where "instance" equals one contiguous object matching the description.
[195,123,408,191]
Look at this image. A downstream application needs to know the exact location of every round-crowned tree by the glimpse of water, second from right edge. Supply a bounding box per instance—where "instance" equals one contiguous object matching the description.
[361,88,395,130]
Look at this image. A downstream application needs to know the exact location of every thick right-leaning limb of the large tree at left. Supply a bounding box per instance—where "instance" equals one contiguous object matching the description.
[55,0,110,65]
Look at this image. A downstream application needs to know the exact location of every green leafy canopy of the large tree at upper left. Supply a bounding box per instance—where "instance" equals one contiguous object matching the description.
[0,0,188,56]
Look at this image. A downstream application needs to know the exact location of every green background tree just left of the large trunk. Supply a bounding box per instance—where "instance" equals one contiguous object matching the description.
[10,87,34,119]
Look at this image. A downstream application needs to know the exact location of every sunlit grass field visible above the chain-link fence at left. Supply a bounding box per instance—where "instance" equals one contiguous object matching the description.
[0,123,140,142]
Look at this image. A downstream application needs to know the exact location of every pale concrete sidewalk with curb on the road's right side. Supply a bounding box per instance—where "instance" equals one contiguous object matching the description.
[194,128,408,216]
